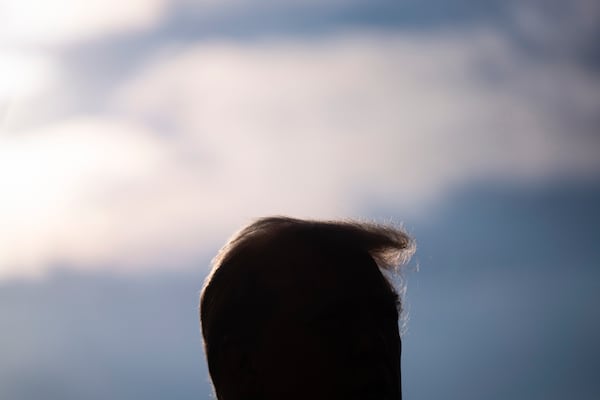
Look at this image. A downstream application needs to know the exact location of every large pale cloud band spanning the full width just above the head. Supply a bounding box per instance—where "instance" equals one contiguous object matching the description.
[0,30,600,275]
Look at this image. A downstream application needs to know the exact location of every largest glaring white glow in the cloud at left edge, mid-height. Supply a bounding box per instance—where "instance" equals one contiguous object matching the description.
[0,119,159,276]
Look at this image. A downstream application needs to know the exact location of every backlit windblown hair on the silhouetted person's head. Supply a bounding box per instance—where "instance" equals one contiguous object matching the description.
[200,216,415,396]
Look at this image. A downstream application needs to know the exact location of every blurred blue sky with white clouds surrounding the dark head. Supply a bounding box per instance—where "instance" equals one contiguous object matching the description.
[0,0,600,400]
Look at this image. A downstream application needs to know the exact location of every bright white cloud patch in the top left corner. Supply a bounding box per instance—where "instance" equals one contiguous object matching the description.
[0,0,167,45]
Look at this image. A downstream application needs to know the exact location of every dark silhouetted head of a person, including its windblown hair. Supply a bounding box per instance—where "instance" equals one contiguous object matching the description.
[200,217,412,400]
